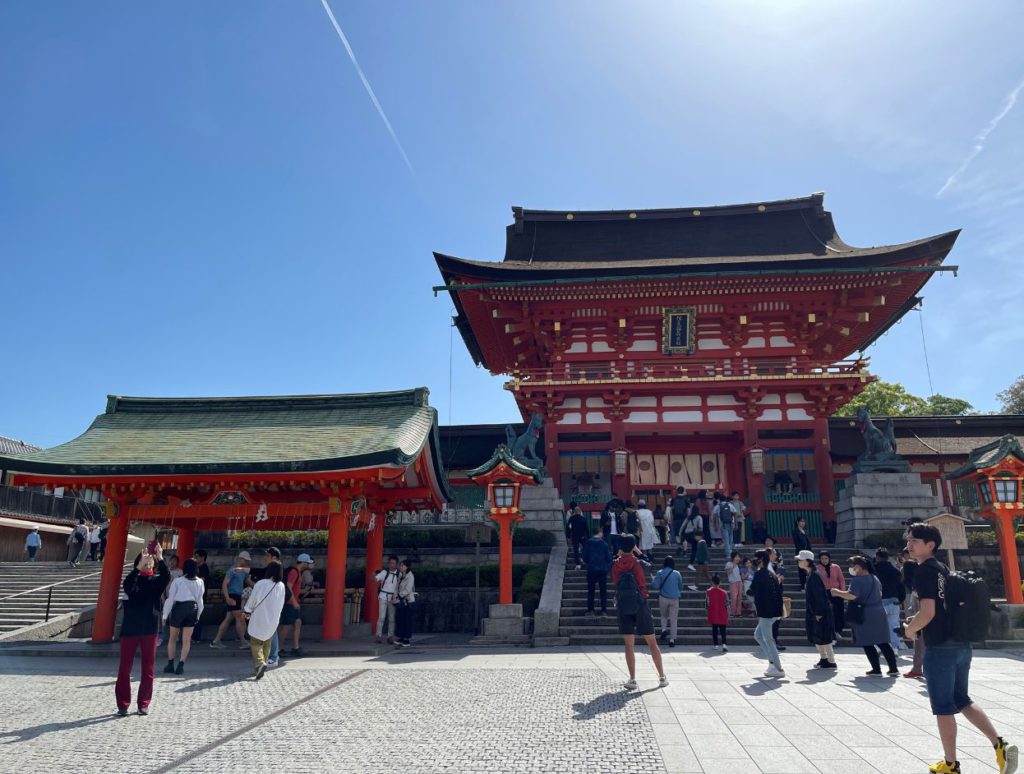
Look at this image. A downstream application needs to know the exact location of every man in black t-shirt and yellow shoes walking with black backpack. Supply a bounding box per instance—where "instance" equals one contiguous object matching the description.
[906,524,1017,774]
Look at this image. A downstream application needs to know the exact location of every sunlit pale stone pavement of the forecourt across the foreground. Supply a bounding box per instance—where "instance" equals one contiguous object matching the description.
[0,648,1024,774]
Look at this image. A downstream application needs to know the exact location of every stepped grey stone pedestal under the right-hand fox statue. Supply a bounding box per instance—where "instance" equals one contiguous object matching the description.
[836,473,942,549]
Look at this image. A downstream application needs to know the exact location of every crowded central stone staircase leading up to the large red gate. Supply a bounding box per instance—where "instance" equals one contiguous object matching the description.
[558,546,860,646]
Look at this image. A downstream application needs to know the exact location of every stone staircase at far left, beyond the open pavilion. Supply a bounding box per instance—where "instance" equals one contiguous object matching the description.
[0,562,115,639]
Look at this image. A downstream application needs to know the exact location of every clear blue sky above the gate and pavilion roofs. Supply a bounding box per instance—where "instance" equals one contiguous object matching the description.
[0,0,1024,445]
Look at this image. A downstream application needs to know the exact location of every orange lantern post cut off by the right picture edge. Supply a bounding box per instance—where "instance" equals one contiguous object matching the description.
[946,435,1024,605]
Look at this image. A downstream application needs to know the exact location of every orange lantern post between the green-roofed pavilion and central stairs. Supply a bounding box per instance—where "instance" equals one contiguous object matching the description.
[468,445,542,605]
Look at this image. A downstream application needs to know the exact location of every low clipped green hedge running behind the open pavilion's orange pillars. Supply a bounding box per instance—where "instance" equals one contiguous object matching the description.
[229,527,555,552]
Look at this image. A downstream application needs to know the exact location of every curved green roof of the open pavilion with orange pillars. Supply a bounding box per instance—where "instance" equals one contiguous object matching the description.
[0,387,445,489]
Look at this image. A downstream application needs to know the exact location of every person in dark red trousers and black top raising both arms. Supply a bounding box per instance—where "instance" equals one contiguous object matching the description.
[114,542,171,718]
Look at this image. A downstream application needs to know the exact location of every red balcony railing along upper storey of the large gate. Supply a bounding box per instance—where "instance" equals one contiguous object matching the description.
[505,357,870,389]
